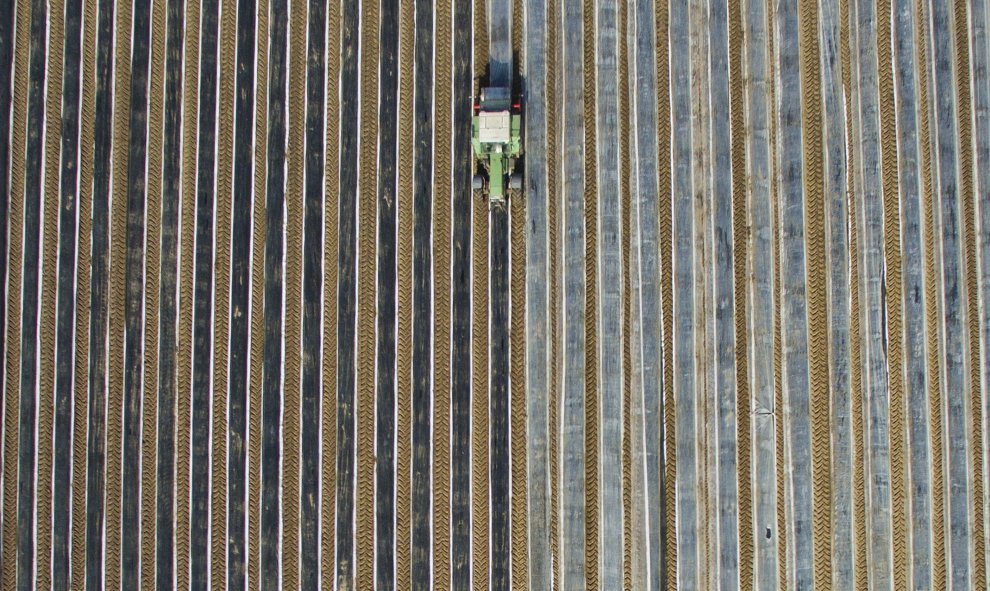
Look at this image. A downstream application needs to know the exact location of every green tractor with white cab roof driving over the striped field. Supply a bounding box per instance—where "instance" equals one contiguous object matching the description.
[471,87,522,205]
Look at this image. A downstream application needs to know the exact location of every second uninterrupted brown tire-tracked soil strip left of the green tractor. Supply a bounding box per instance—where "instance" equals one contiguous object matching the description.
[396,1,415,589]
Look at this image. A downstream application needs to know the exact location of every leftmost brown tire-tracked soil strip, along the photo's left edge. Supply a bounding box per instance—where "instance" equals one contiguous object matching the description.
[0,2,27,589]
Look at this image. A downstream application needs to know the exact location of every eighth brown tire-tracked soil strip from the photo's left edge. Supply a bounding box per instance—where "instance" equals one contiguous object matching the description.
[247,0,266,589]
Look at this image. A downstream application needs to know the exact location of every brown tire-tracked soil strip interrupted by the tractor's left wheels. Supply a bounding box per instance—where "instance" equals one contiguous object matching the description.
[471,0,490,591]
